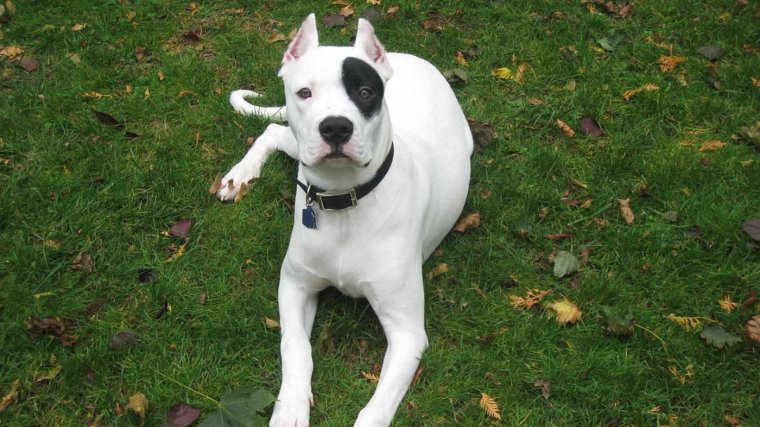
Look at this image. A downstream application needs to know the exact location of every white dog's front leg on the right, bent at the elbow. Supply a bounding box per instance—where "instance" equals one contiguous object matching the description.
[354,270,428,427]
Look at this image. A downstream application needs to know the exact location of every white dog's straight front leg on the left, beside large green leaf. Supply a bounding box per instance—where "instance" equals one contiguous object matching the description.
[269,270,317,427]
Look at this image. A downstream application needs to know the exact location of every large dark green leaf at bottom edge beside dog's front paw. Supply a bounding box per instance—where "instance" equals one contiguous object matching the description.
[198,387,275,427]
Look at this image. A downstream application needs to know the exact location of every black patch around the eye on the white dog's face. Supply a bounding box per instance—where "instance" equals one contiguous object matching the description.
[343,58,385,118]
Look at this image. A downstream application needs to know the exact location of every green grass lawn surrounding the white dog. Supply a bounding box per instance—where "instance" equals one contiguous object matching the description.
[0,0,760,426]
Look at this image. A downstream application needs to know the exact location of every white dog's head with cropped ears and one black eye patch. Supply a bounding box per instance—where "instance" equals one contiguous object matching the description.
[279,14,393,172]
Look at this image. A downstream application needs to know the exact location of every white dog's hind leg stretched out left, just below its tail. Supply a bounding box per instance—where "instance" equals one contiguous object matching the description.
[216,124,298,201]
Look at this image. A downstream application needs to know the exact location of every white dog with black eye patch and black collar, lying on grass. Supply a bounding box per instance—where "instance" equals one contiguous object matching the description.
[216,14,473,427]
